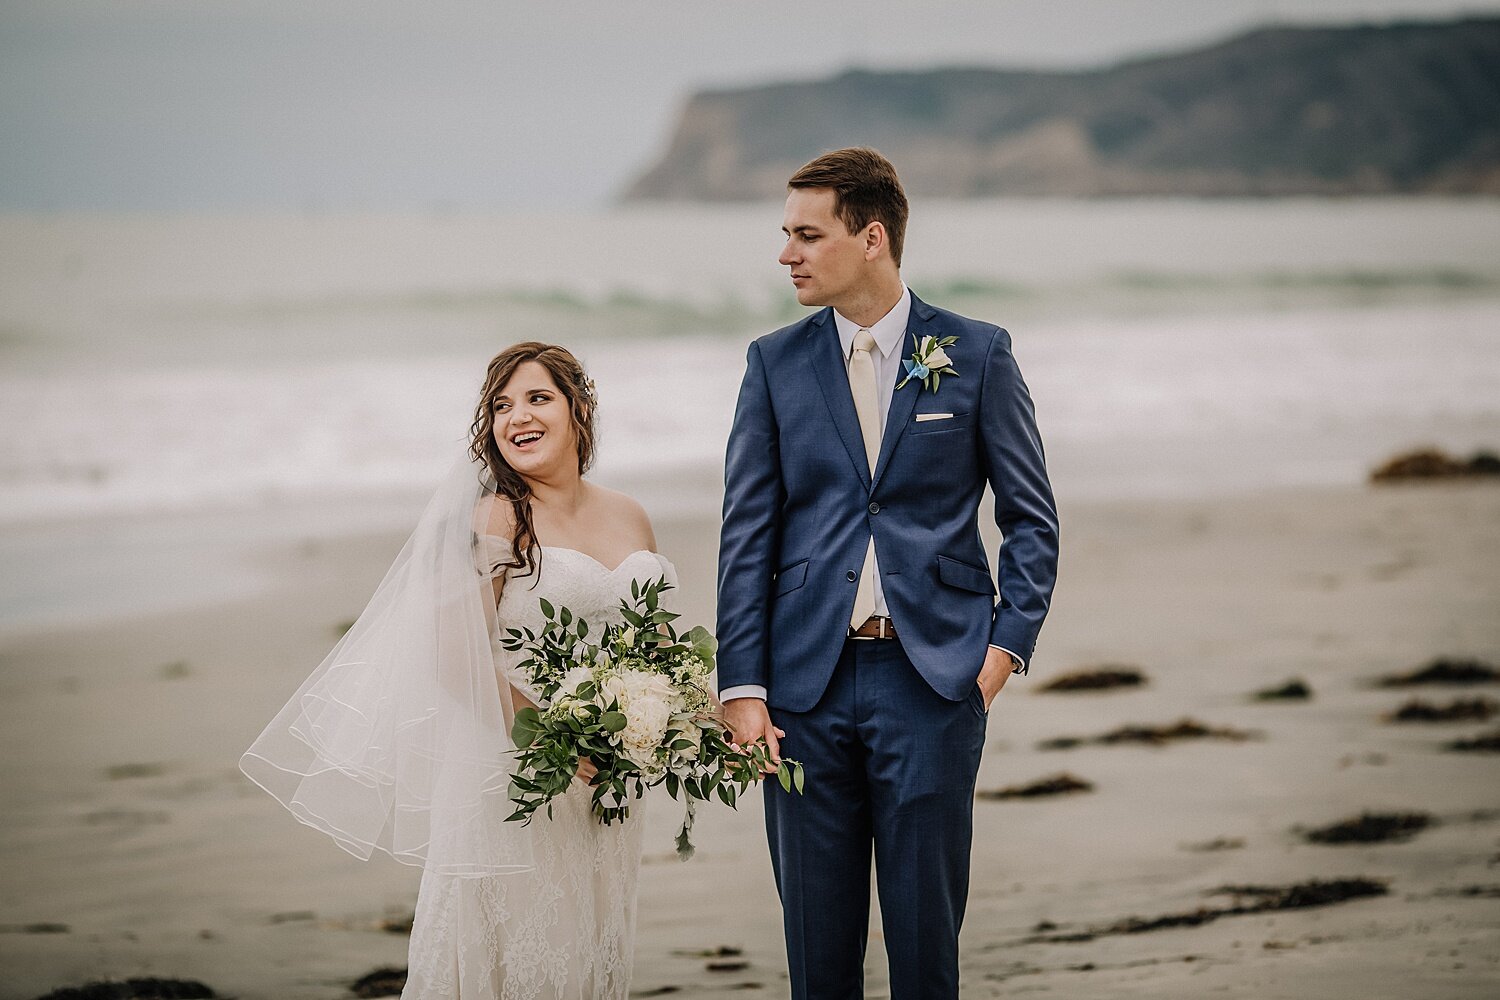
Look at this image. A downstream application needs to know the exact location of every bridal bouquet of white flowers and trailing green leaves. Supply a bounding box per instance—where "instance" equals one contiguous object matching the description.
[501,577,804,861]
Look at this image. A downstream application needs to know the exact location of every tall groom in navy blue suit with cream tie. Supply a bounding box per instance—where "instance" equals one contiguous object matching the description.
[719,148,1058,1000]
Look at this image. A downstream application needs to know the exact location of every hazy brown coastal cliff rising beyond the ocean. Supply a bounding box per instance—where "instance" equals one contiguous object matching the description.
[624,18,1500,201]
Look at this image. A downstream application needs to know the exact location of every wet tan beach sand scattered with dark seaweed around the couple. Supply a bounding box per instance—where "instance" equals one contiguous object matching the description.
[0,484,1500,1000]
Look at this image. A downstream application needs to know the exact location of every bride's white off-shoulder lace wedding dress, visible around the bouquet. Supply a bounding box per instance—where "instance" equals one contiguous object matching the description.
[401,548,677,1000]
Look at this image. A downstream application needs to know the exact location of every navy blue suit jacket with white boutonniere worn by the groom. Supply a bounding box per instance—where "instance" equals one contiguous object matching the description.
[719,295,1058,712]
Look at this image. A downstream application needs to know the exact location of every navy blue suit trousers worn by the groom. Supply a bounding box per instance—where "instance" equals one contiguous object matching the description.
[765,639,986,1000]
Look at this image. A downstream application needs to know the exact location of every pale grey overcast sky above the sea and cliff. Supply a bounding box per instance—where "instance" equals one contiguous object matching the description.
[0,0,1500,210]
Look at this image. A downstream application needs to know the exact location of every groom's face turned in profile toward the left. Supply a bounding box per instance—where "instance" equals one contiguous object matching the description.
[779,187,869,309]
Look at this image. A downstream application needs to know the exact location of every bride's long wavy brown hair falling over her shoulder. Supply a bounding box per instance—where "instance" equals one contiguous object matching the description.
[470,340,597,576]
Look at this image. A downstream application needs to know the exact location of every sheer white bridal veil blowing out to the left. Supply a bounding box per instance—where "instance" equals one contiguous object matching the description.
[240,456,531,877]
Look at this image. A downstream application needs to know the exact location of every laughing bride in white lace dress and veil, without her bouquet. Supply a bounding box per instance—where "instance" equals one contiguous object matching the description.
[240,343,677,1000]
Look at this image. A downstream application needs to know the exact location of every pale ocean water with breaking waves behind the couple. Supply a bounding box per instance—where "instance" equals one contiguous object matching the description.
[0,199,1500,628]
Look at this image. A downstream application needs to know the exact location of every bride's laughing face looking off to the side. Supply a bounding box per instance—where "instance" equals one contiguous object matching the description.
[491,361,578,478]
